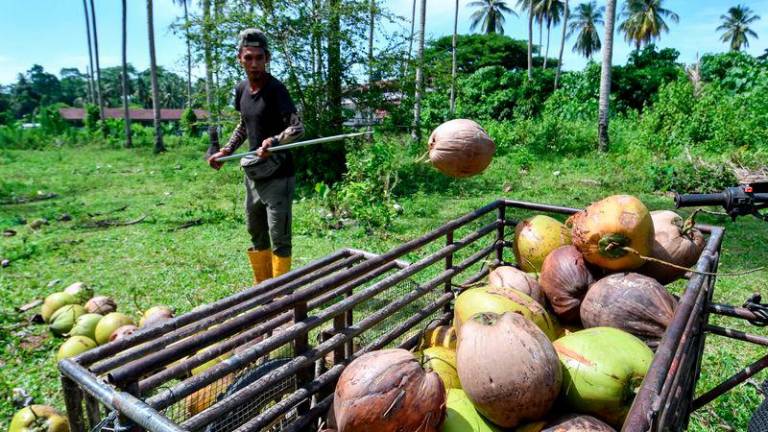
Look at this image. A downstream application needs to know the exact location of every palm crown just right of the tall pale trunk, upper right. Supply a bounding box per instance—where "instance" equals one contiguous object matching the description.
[619,0,680,51]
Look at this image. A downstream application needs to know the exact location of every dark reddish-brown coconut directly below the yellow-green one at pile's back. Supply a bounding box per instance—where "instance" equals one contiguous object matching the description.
[539,246,595,323]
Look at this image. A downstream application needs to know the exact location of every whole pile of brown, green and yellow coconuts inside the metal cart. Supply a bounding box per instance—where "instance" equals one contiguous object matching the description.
[320,195,704,432]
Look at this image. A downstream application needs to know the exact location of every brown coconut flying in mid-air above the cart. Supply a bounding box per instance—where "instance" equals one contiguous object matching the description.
[429,119,496,178]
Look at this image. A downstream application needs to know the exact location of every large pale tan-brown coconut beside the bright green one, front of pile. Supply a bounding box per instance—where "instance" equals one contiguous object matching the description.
[456,312,562,428]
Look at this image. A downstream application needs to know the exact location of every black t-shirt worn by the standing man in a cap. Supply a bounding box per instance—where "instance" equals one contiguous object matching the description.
[235,75,296,178]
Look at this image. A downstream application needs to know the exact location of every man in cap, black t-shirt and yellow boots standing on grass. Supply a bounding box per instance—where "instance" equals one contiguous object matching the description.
[208,28,304,283]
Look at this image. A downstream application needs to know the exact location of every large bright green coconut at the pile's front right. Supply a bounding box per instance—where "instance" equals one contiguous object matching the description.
[554,327,653,427]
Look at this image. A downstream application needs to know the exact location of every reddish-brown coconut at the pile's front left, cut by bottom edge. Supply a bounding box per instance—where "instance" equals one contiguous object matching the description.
[333,349,446,432]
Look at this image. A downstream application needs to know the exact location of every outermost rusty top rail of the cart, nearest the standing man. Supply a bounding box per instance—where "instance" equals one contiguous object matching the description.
[75,250,350,366]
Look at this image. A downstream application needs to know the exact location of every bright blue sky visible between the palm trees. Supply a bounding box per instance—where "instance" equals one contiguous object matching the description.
[0,0,768,85]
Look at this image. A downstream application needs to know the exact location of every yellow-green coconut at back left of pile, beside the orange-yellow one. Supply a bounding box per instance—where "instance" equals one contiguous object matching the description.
[512,215,571,273]
